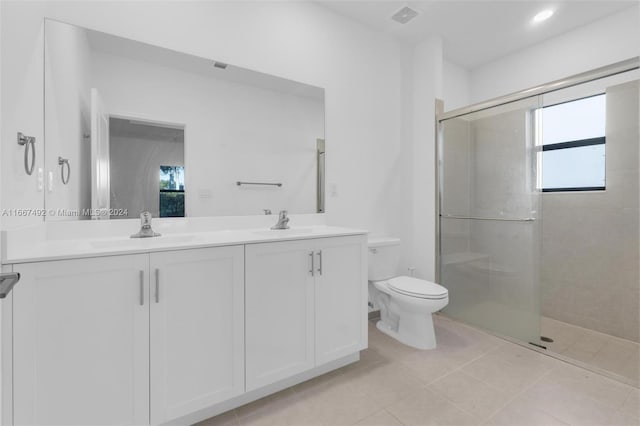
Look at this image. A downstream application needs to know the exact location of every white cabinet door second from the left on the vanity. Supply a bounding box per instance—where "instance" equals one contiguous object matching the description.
[150,246,244,424]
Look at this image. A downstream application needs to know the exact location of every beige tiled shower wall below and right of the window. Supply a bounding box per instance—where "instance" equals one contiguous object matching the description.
[541,81,640,342]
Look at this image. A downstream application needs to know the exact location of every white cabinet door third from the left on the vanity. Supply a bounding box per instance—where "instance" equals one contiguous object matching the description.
[245,241,314,391]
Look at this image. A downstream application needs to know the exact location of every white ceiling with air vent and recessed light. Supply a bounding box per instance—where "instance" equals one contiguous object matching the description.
[318,0,640,69]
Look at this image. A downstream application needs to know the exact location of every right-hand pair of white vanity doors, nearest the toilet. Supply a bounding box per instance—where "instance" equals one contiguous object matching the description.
[245,236,367,391]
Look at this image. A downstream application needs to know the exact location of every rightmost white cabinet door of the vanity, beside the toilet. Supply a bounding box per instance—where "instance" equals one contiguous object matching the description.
[315,236,367,365]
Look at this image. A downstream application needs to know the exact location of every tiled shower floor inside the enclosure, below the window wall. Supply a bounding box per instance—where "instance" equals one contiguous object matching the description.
[540,317,640,386]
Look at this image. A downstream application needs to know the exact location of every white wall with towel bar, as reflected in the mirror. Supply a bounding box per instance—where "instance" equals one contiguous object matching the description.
[92,53,322,217]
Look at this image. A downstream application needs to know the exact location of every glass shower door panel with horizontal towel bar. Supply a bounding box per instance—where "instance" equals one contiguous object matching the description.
[438,97,541,344]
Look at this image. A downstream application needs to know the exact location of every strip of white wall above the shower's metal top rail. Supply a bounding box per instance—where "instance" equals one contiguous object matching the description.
[471,6,640,103]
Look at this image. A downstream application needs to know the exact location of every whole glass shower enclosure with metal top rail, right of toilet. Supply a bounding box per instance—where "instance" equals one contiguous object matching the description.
[436,58,640,380]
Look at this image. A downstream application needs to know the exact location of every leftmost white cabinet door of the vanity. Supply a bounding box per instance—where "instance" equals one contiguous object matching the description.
[13,255,149,425]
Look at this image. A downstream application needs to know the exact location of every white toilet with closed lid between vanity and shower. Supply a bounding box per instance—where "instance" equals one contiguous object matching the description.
[369,237,449,349]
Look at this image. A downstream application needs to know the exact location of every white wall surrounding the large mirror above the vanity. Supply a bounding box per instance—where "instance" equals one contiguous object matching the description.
[1,1,410,243]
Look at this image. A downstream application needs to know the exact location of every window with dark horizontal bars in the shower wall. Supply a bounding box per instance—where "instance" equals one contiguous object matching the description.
[538,94,606,192]
